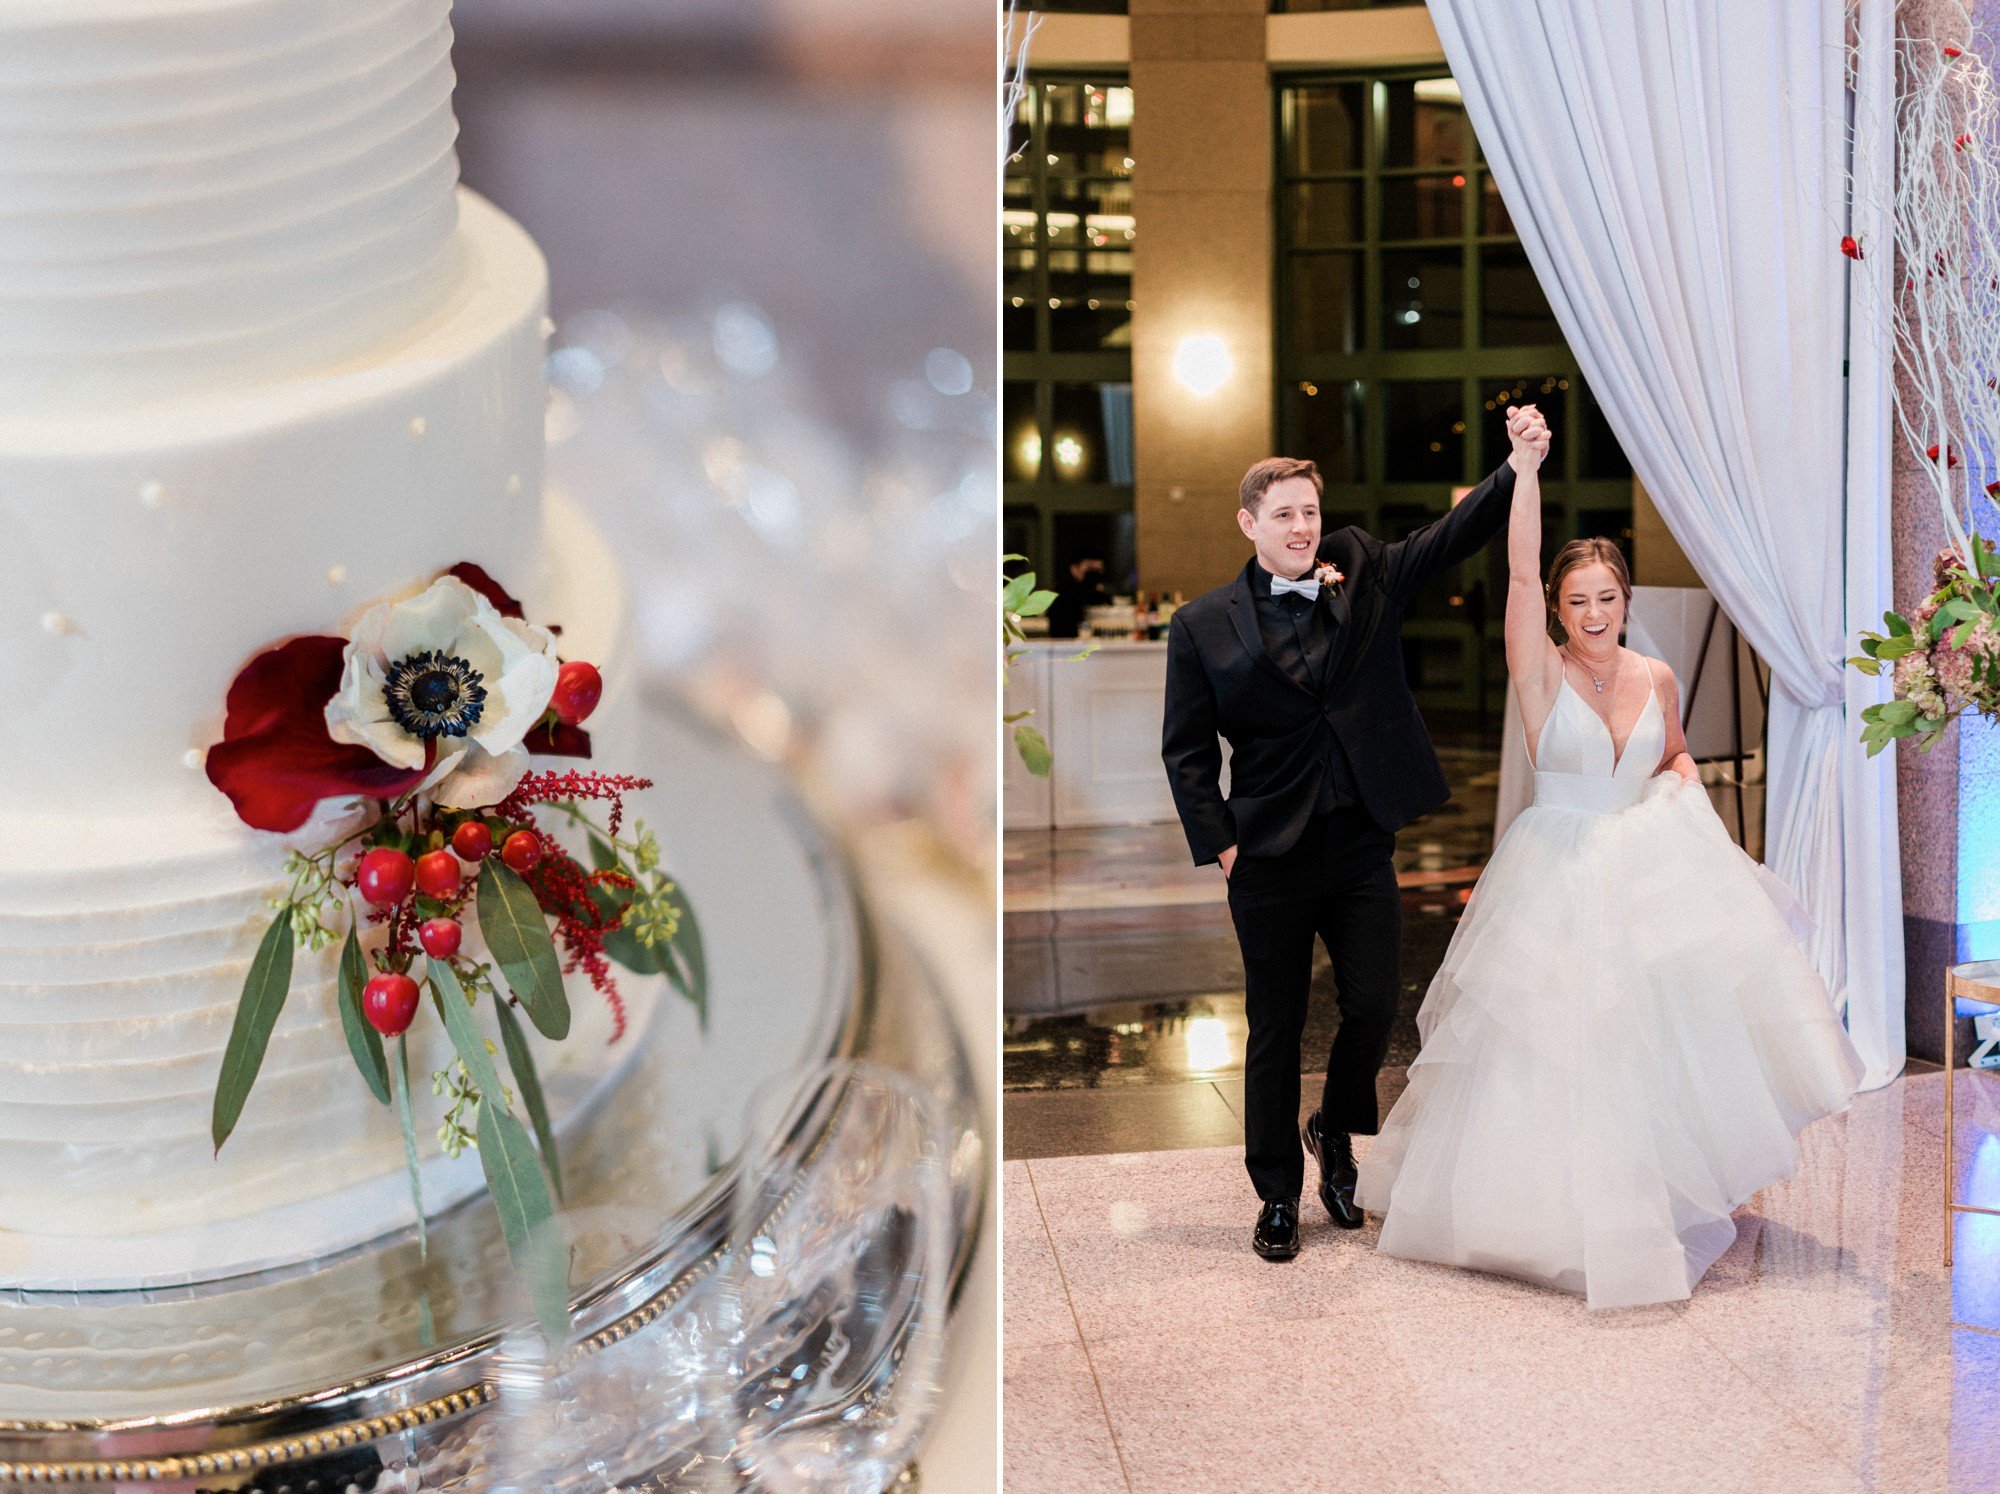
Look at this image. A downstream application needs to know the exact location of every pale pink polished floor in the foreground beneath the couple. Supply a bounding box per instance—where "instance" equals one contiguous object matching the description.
[1004,1072,2000,1494]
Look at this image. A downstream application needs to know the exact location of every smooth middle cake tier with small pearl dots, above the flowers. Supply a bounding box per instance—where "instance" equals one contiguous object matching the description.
[0,192,548,820]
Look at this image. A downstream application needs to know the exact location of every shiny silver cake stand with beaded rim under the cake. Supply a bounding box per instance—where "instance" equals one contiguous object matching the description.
[0,698,988,1494]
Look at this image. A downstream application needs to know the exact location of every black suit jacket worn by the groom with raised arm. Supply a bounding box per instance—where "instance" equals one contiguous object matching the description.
[1160,466,1514,866]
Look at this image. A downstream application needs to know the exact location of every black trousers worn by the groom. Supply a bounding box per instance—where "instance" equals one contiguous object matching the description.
[1230,808,1402,1200]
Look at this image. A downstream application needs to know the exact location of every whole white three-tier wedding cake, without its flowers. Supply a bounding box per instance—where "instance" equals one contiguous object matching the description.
[0,0,642,1282]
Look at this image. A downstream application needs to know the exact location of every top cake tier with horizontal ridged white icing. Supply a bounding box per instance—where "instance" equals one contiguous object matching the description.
[0,0,458,408]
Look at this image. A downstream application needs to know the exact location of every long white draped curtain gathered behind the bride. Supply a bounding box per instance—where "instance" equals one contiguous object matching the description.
[1430,0,1904,1086]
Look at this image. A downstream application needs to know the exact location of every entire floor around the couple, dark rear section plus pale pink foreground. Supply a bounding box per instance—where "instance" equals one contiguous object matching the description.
[1004,746,2000,1494]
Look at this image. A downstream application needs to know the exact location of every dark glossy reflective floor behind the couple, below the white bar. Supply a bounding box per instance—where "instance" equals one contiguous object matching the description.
[1004,746,1498,1158]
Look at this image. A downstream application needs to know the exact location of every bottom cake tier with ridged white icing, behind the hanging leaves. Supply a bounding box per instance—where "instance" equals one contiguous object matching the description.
[0,504,636,1236]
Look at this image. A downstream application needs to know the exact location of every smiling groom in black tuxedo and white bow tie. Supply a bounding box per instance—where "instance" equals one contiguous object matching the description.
[1162,432,1546,1260]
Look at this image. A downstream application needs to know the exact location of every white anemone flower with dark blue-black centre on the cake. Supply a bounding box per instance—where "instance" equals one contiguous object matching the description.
[326,576,558,810]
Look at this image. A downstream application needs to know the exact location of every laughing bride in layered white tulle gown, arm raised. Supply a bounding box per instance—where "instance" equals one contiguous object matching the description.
[1356,406,1862,1308]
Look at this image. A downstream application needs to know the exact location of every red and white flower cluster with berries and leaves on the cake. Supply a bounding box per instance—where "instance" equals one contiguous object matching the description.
[206,564,708,1336]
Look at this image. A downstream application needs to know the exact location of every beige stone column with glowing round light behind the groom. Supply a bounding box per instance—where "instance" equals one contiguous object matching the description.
[1132,0,1274,596]
